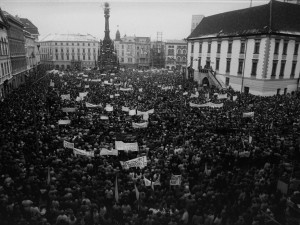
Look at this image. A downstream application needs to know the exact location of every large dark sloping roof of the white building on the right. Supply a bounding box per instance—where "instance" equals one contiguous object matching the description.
[188,0,300,39]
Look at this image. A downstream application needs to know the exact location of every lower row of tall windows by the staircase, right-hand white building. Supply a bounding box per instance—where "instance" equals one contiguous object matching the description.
[195,57,297,78]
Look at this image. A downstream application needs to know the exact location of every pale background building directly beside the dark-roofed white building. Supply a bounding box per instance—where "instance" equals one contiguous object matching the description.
[165,40,187,70]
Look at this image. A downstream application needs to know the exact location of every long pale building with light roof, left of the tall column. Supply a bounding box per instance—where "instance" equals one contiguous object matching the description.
[39,34,99,70]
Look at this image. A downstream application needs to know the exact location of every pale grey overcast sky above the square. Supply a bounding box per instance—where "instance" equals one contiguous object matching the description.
[0,0,269,40]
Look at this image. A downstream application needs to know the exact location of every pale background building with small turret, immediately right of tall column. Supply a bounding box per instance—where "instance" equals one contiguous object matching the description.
[114,31,151,68]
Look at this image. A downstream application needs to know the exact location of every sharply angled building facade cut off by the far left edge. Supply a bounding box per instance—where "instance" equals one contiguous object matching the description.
[0,8,12,100]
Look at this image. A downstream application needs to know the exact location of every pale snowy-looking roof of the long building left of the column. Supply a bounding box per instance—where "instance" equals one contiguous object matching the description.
[40,34,98,42]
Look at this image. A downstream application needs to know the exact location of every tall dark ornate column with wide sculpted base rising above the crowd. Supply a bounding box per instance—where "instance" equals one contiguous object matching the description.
[98,2,119,73]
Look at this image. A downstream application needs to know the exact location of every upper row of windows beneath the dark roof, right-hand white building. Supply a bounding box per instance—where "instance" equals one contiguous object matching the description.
[191,40,299,55]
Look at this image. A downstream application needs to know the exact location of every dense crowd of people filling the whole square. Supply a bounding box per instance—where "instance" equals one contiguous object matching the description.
[0,67,300,225]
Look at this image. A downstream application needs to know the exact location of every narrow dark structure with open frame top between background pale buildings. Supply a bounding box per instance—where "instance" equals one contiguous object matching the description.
[151,32,165,68]
